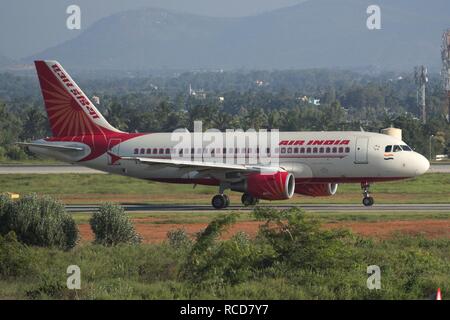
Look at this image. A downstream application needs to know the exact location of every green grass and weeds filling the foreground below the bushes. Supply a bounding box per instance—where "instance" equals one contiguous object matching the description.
[0,237,450,299]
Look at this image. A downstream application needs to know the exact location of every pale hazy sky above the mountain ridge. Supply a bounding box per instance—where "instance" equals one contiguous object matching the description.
[0,0,306,59]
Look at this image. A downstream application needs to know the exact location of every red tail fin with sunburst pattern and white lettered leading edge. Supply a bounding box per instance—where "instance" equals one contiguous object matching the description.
[34,61,121,137]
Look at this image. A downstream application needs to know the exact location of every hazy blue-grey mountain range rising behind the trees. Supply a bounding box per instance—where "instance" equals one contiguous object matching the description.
[22,0,450,70]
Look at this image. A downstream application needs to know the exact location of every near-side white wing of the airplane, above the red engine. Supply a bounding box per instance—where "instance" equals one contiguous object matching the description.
[121,157,270,173]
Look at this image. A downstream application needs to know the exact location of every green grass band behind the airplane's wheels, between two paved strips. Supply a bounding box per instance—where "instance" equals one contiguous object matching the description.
[0,173,450,204]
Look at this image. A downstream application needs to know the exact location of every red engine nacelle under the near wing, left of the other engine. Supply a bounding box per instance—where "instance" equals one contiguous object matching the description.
[231,171,295,200]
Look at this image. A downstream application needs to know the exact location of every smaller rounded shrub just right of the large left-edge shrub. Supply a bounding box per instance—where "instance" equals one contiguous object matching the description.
[89,203,142,246]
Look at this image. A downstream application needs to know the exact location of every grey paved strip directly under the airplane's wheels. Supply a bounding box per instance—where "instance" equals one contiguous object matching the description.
[65,203,450,213]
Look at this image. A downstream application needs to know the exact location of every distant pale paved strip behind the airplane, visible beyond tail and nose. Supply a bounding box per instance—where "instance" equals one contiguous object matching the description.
[0,164,450,174]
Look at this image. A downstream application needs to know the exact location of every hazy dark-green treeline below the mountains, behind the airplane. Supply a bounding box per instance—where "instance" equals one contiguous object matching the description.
[0,70,450,160]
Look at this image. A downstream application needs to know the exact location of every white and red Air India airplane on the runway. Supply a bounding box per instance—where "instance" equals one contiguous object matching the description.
[20,60,430,209]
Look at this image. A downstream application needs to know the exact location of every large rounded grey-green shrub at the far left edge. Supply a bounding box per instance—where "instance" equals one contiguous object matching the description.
[0,194,78,250]
